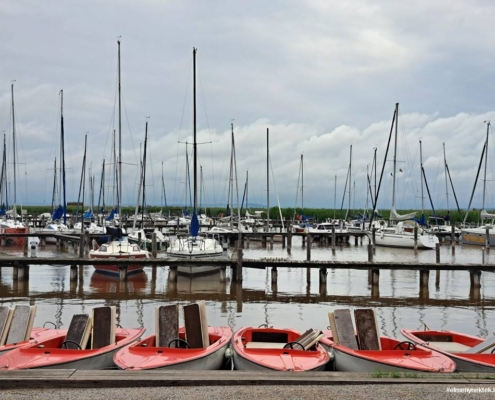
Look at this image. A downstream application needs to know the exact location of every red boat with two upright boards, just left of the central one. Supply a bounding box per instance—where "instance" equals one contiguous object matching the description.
[114,302,232,371]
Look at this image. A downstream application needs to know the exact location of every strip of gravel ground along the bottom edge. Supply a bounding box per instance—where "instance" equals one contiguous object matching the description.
[0,384,495,400]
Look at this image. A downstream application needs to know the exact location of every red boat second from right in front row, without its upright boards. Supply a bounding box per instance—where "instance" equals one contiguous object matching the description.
[320,330,456,372]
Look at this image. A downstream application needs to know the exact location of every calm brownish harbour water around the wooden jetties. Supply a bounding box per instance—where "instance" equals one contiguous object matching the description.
[0,238,495,337]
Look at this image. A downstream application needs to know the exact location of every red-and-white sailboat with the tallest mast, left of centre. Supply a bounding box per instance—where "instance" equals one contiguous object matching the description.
[89,40,151,274]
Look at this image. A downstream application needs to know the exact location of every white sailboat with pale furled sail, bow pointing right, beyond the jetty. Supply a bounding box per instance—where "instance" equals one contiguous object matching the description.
[367,103,439,249]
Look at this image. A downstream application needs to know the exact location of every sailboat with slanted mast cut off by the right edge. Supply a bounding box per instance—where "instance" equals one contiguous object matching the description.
[461,121,495,246]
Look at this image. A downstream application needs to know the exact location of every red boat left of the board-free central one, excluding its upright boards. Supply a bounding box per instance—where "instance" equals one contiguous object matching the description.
[113,326,232,370]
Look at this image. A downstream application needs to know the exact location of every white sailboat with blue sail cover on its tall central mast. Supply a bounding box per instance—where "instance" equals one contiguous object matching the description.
[167,48,223,266]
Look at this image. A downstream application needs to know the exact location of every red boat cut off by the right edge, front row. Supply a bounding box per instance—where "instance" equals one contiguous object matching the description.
[401,329,495,373]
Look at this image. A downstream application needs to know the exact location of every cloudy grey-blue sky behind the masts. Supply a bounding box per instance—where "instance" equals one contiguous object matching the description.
[0,0,495,216]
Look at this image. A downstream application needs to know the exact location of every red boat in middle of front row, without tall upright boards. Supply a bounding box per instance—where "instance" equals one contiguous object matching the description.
[233,328,330,371]
